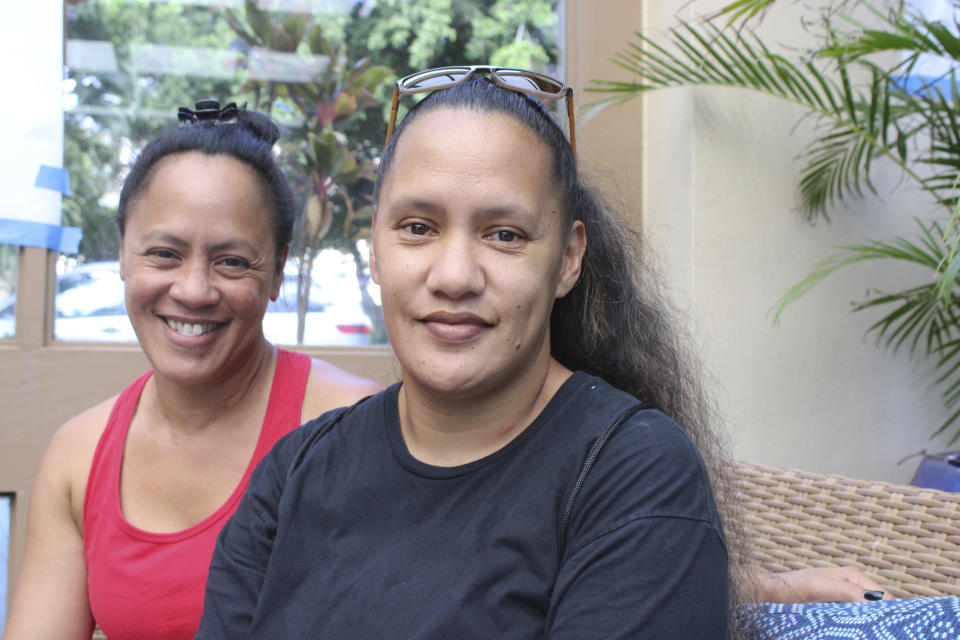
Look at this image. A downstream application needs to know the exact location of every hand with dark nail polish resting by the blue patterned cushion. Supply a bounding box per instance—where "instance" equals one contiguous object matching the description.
[754,567,893,604]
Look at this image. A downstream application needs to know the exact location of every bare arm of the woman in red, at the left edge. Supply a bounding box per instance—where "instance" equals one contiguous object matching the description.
[3,408,106,640]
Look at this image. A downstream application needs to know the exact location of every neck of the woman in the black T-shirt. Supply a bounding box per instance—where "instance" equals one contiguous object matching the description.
[398,358,572,467]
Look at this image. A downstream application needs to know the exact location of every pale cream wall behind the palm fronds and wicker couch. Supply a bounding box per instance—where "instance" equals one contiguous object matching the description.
[636,0,946,482]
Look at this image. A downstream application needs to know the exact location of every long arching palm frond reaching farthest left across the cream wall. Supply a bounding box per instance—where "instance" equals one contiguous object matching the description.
[588,21,927,218]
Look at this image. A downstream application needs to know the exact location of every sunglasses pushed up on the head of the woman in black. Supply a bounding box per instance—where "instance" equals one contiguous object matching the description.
[384,65,577,161]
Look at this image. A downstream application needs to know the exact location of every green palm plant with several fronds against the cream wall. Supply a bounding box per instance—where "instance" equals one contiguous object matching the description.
[591,0,960,443]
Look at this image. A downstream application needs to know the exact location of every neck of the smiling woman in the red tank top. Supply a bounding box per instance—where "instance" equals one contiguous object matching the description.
[141,340,276,435]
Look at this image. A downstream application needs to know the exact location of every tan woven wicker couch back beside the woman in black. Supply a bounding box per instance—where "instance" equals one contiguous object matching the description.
[737,463,960,598]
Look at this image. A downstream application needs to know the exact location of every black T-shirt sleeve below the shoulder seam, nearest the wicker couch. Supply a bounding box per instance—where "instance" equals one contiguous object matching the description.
[547,518,728,640]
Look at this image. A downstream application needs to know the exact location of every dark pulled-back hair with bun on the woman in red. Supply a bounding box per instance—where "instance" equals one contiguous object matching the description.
[116,107,294,256]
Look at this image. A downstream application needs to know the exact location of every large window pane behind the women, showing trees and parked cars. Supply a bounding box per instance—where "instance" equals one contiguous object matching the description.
[62,0,559,345]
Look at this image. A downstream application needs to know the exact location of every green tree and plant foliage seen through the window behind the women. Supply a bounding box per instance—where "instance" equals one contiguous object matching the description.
[64,0,559,344]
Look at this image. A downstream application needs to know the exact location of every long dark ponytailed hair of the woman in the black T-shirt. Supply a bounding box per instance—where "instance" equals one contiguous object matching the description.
[374,77,746,635]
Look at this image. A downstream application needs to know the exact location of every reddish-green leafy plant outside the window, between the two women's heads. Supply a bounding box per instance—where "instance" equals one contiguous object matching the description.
[226,0,392,344]
